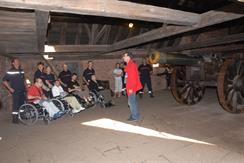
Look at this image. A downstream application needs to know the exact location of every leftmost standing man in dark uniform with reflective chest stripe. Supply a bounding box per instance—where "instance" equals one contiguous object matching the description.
[3,58,26,123]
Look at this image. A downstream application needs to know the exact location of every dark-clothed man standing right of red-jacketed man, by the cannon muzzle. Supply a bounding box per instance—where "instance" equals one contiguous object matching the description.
[138,58,154,97]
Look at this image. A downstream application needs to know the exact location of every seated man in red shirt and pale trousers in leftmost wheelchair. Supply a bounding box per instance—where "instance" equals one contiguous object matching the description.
[27,78,63,118]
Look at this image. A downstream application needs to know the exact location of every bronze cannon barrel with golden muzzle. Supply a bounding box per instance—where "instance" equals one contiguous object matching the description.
[149,50,202,66]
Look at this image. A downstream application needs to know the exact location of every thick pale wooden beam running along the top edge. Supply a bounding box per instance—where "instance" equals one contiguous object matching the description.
[0,0,200,25]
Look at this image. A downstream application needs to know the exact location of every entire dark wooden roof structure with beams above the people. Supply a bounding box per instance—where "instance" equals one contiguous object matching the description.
[0,0,244,59]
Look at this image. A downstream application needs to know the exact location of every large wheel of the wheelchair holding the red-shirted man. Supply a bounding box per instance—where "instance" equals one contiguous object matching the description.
[18,104,39,125]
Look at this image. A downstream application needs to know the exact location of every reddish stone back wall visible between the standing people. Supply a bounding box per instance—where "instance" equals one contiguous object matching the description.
[0,56,165,110]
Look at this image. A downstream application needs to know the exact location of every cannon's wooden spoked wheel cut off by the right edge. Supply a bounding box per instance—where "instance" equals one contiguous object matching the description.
[217,59,244,113]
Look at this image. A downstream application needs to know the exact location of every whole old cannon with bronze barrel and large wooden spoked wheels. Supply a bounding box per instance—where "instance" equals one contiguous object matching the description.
[148,50,244,113]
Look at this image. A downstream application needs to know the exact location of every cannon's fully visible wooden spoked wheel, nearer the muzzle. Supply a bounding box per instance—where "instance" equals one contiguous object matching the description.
[171,66,205,105]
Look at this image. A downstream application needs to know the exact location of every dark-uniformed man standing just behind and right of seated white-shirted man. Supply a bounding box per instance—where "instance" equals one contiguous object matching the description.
[58,64,72,92]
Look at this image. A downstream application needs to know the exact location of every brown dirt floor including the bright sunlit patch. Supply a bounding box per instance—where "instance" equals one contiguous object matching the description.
[0,89,244,163]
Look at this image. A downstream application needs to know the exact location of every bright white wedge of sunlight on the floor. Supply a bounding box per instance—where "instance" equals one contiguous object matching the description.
[81,118,215,146]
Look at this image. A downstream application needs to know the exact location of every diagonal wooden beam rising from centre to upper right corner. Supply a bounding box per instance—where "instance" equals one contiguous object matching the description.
[110,5,244,51]
